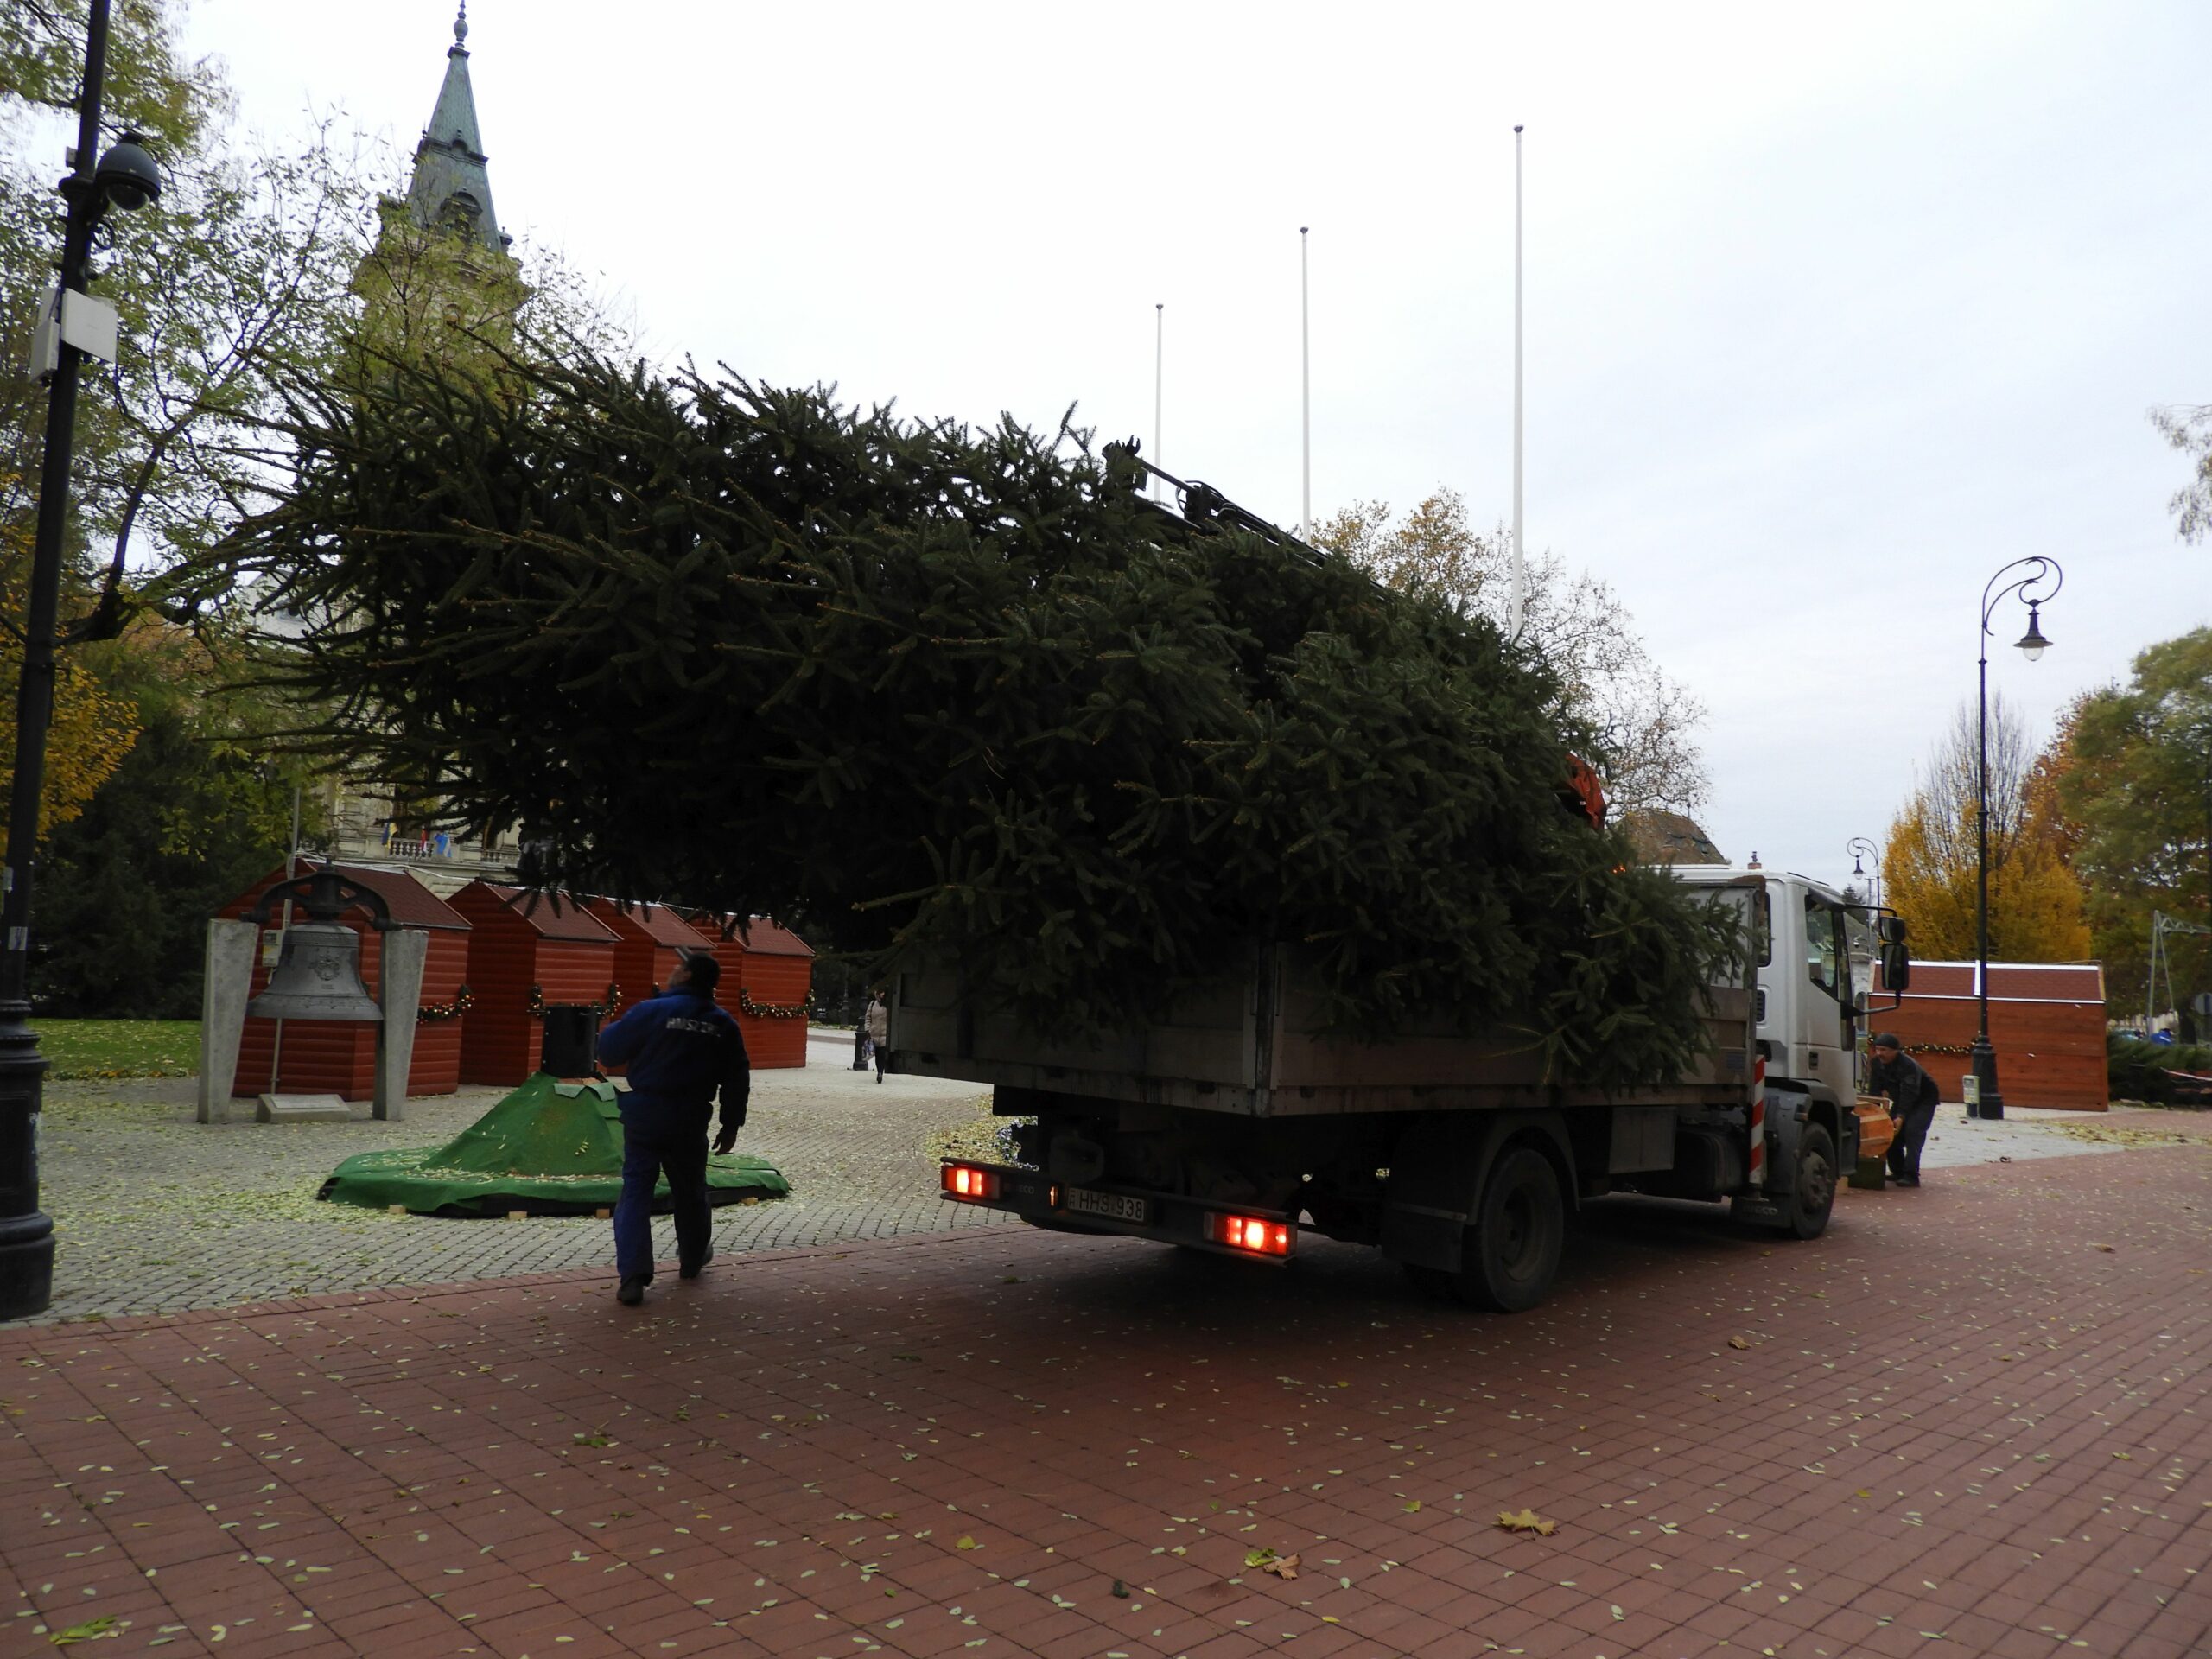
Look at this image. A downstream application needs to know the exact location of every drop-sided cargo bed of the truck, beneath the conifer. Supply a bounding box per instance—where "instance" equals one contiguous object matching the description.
[889,953,1754,1117]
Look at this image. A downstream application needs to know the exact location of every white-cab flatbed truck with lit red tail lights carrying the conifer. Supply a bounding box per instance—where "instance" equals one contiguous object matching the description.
[887,865,1909,1312]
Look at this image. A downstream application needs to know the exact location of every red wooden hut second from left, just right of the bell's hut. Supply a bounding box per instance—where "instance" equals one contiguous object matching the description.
[449,880,621,1089]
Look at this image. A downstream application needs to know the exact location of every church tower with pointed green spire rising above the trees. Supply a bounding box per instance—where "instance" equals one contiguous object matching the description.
[354,0,531,374]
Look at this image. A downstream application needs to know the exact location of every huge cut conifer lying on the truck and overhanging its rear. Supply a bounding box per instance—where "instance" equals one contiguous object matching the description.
[226,356,1723,1084]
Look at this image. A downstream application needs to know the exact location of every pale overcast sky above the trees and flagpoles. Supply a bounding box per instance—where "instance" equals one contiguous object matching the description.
[190,0,2212,911]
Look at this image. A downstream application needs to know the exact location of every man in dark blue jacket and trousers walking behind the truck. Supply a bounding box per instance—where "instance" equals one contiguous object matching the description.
[600,951,752,1307]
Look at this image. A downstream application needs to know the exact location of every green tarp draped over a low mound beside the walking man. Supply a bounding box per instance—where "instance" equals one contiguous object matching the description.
[316,1073,791,1217]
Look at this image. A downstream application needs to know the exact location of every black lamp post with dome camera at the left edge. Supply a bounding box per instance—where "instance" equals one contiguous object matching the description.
[0,0,162,1319]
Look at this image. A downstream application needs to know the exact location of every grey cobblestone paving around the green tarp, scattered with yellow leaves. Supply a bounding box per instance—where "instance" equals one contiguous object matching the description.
[40,1033,1004,1320]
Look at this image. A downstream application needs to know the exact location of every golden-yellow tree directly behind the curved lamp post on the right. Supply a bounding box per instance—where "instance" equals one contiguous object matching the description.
[1883,695,2090,963]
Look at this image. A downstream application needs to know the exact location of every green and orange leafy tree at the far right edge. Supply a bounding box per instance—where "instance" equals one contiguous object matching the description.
[2057,628,2212,1011]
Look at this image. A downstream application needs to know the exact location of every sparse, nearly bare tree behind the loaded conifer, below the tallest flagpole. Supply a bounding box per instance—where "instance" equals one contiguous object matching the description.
[1314,489,1710,812]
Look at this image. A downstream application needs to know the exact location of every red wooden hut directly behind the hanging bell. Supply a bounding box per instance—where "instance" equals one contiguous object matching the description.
[219,865,469,1099]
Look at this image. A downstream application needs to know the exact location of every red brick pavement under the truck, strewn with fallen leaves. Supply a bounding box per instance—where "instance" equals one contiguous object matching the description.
[0,1144,2212,1659]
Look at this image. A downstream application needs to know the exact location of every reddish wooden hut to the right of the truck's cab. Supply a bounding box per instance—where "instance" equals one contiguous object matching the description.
[1867,963,2110,1113]
